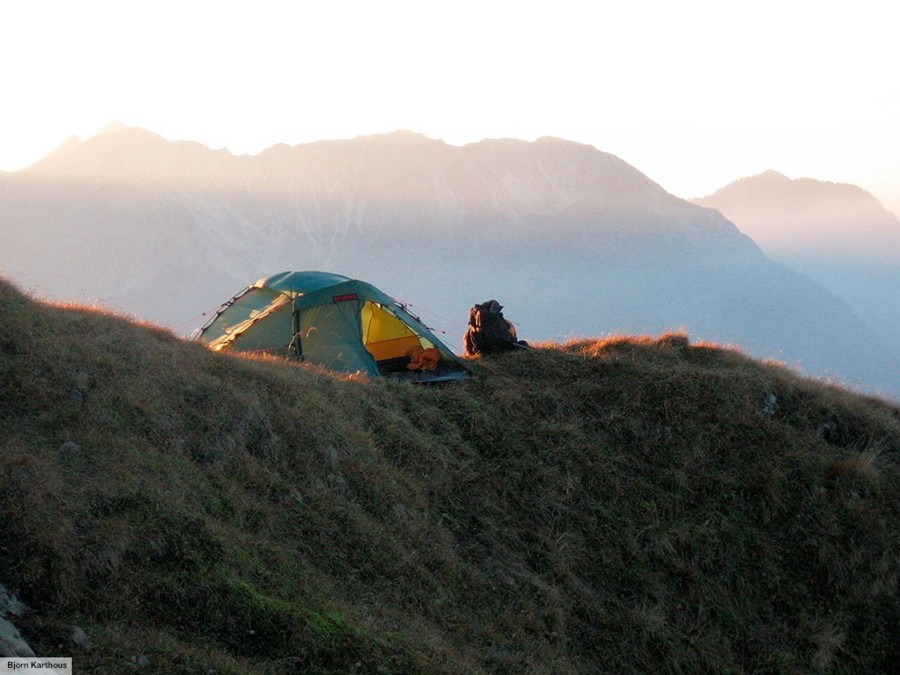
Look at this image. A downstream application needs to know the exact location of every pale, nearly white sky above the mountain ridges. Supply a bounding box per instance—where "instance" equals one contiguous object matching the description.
[0,0,900,214]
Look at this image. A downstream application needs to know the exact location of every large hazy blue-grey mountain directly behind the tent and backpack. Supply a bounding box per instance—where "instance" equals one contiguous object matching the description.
[0,127,900,397]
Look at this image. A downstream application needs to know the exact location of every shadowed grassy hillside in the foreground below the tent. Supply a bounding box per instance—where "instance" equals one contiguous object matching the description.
[0,282,900,673]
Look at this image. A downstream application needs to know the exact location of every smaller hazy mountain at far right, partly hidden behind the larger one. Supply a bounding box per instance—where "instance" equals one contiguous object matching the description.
[694,171,900,356]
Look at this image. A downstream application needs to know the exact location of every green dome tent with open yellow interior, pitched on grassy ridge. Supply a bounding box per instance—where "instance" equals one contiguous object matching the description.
[197,272,467,382]
